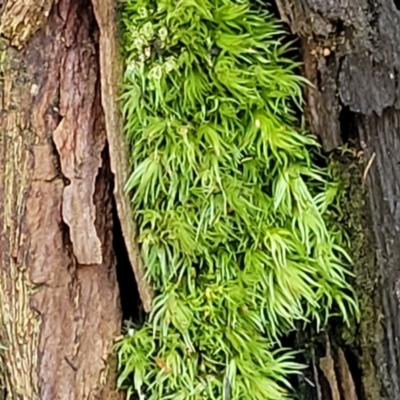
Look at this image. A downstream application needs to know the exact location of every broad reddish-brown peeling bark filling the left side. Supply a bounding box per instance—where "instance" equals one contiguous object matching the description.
[0,0,121,400]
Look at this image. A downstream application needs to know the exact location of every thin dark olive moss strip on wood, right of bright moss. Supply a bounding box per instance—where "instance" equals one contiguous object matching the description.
[331,147,384,400]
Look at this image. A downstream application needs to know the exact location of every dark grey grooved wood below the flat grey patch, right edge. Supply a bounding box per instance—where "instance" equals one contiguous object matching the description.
[357,108,400,400]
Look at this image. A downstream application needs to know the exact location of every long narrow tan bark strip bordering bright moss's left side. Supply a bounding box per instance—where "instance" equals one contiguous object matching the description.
[92,0,153,313]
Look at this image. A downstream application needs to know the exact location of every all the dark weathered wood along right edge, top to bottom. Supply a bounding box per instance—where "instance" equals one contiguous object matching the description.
[277,0,400,400]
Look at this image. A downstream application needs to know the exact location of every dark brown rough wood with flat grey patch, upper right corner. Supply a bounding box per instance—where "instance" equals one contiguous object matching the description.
[276,0,400,151]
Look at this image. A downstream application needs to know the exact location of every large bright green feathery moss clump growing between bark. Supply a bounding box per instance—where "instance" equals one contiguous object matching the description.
[118,0,356,400]
